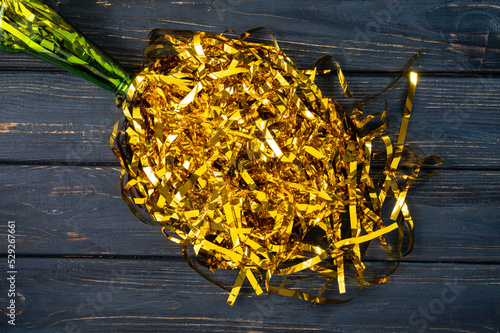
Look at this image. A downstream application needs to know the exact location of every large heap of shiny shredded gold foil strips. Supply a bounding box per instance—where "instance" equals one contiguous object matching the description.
[111,30,426,305]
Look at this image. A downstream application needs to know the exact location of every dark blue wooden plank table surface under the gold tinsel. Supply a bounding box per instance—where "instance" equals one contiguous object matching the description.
[0,0,500,332]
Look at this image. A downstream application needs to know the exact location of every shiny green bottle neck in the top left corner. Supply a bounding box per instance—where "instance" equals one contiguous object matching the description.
[0,0,133,96]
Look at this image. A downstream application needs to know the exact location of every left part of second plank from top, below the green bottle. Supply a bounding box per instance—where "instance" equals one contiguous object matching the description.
[0,72,122,163]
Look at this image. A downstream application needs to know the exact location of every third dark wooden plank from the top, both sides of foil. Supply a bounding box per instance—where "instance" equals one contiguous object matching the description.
[0,165,500,263]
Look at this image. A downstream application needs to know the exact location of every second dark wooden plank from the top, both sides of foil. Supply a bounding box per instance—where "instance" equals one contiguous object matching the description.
[0,72,500,168]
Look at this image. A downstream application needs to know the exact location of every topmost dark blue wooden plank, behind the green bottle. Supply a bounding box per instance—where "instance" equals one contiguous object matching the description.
[0,0,500,72]
